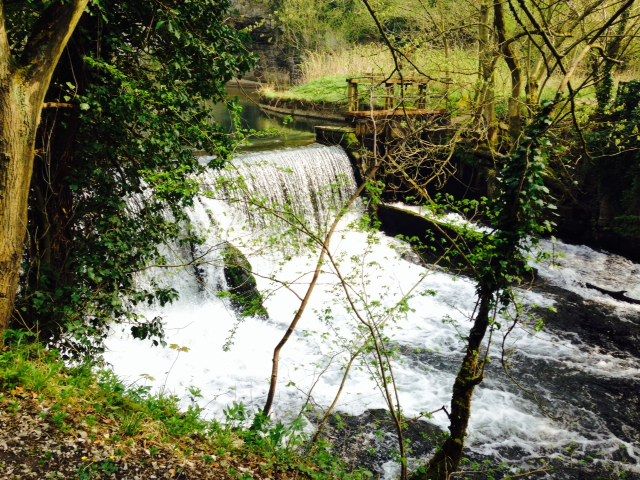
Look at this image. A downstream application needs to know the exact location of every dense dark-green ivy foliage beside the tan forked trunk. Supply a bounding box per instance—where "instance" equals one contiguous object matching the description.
[19,0,252,350]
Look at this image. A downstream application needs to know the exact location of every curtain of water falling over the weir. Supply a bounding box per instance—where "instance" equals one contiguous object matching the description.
[148,144,356,301]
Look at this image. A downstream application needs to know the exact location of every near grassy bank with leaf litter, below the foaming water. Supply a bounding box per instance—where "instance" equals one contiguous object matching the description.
[0,336,368,480]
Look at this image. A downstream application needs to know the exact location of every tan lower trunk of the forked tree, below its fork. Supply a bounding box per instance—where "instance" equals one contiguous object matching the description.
[0,78,39,334]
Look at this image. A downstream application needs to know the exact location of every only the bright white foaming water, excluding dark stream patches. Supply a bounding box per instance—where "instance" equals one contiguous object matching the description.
[105,147,640,478]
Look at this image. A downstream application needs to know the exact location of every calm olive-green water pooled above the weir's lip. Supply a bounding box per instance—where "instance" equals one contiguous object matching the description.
[212,86,342,150]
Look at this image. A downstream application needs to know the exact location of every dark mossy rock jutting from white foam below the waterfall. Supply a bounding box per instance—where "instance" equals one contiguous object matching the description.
[222,242,269,318]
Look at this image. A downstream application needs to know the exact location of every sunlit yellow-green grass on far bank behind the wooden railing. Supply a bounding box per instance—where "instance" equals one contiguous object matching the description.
[262,43,594,118]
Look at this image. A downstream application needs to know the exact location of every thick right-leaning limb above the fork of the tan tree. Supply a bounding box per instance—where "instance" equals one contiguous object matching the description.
[20,0,89,86]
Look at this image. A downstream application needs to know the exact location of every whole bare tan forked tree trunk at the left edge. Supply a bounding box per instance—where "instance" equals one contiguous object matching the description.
[0,0,88,341]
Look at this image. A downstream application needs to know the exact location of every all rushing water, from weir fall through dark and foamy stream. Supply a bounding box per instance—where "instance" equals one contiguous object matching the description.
[105,146,640,479]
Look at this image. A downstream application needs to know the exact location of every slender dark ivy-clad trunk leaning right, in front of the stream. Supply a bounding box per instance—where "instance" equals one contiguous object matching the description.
[412,103,556,480]
